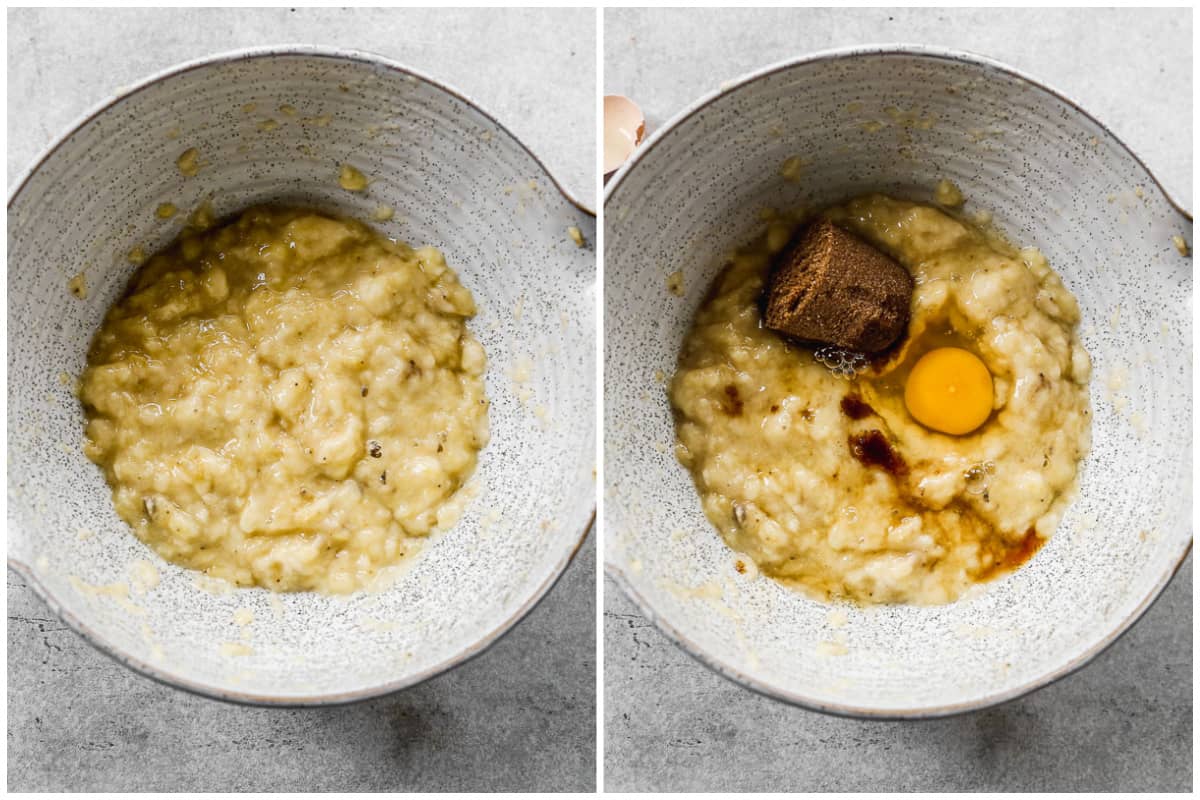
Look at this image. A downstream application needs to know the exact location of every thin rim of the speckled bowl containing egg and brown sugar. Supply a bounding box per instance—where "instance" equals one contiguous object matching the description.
[604,44,1193,720]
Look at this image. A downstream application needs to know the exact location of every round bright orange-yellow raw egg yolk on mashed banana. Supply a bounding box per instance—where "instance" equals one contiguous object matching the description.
[904,347,992,435]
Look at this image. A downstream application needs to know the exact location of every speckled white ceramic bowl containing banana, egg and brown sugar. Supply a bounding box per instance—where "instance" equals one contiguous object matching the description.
[605,47,1192,717]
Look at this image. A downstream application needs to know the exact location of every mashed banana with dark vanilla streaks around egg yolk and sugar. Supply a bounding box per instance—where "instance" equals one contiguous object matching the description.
[670,196,1091,603]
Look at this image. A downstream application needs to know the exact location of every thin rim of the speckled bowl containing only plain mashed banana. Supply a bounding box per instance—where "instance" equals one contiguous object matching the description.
[7,44,596,708]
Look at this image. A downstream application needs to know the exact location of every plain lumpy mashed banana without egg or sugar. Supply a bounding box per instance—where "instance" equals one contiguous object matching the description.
[80,207,487,593]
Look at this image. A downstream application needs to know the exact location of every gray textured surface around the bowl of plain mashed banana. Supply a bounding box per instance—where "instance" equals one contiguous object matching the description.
[7,8,595,792]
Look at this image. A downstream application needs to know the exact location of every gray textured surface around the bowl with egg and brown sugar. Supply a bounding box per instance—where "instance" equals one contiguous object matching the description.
[604,8,1192,792]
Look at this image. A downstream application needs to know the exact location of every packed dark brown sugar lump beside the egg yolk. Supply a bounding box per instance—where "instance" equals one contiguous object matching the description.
[767,218,913,353]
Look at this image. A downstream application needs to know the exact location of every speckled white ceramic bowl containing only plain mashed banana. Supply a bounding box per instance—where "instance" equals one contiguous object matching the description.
[8,47,595,704]
